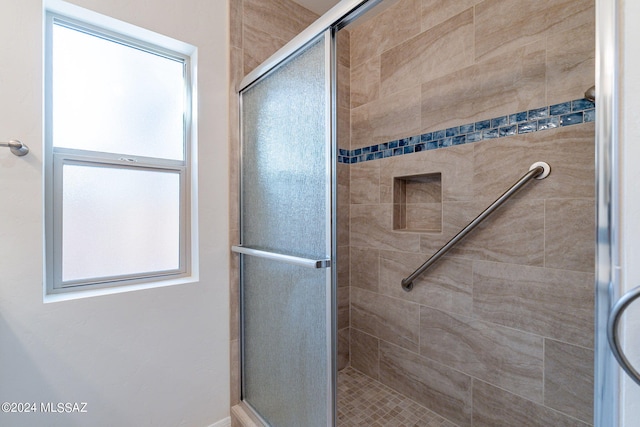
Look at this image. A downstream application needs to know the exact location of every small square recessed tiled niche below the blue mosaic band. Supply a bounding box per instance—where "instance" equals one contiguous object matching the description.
[393,172,442,233]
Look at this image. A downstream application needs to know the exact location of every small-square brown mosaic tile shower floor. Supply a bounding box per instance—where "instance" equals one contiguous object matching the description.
[338,367,456,427]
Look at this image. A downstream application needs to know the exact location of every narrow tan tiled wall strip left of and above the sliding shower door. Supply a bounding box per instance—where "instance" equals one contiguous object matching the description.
[229,0,318,412]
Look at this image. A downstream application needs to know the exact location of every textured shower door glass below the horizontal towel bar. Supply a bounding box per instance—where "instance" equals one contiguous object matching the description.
[243,257,329,427]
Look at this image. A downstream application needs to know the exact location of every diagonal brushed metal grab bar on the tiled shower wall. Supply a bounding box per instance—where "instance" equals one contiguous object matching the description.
[401,162,551,292]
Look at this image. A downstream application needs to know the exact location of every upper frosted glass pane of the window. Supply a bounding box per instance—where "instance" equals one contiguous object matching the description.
[52,24,185,160]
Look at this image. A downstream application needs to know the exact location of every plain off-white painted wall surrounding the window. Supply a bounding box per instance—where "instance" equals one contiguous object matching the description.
[0,0,229,427]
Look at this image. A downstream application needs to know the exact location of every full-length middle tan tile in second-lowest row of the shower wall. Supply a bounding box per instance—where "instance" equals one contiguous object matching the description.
[420,306,543,403]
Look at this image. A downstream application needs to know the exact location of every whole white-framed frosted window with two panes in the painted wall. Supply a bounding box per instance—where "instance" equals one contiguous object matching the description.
[45,13,192,294]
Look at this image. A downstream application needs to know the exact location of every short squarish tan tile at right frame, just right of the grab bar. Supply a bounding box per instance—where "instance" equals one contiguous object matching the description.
[544,199,596,273]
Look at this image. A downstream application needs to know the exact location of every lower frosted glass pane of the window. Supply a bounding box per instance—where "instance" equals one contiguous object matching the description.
[62,164,180,281]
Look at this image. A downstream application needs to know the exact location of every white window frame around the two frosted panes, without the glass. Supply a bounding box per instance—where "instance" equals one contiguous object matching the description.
[44,0,197,302]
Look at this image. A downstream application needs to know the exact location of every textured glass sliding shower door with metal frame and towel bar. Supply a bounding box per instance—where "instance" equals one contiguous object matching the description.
[234,32,335,427]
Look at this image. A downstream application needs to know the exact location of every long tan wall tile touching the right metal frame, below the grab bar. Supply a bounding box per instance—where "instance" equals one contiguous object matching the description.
[473,261,594,348]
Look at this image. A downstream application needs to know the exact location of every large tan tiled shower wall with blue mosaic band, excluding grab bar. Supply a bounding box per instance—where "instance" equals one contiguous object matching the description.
[348,0,595,426]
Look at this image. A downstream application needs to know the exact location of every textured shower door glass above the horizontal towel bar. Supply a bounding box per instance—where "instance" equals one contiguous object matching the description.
[242,39,329,258]
